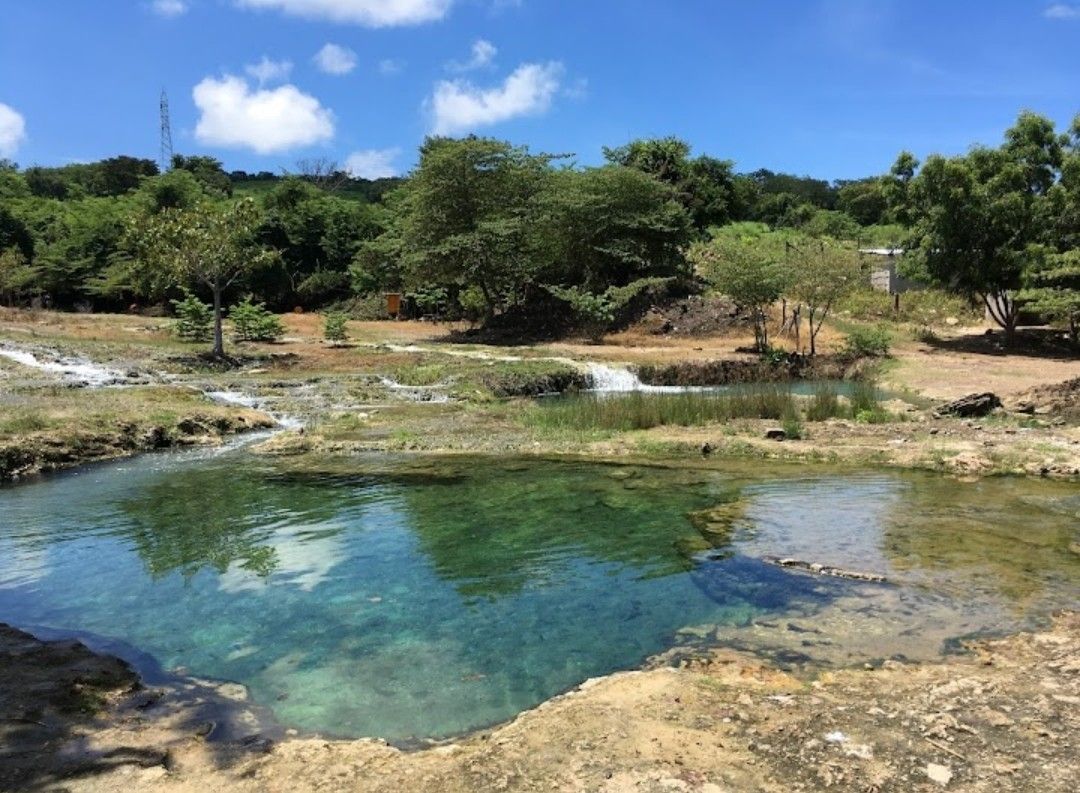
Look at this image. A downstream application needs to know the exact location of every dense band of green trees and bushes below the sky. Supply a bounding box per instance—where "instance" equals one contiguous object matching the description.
[0,112,1080,352]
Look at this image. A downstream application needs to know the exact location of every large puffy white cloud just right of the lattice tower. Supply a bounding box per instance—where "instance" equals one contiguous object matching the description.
[191,75,334,154]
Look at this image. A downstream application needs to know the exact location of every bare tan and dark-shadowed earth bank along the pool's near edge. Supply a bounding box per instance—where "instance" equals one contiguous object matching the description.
[0,613,1080,793]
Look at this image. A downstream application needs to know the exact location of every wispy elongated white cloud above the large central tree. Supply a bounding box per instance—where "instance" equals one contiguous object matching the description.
[430,62,563,135]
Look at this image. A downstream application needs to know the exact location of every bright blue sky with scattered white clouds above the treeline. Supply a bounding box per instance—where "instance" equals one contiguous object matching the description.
[0,0,1080,178]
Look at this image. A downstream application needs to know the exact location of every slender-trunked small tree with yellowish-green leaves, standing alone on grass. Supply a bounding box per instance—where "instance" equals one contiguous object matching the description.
[130,199,276,358]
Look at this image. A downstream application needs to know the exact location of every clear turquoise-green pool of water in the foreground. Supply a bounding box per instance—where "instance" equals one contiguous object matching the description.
[0,451,1080,741]
